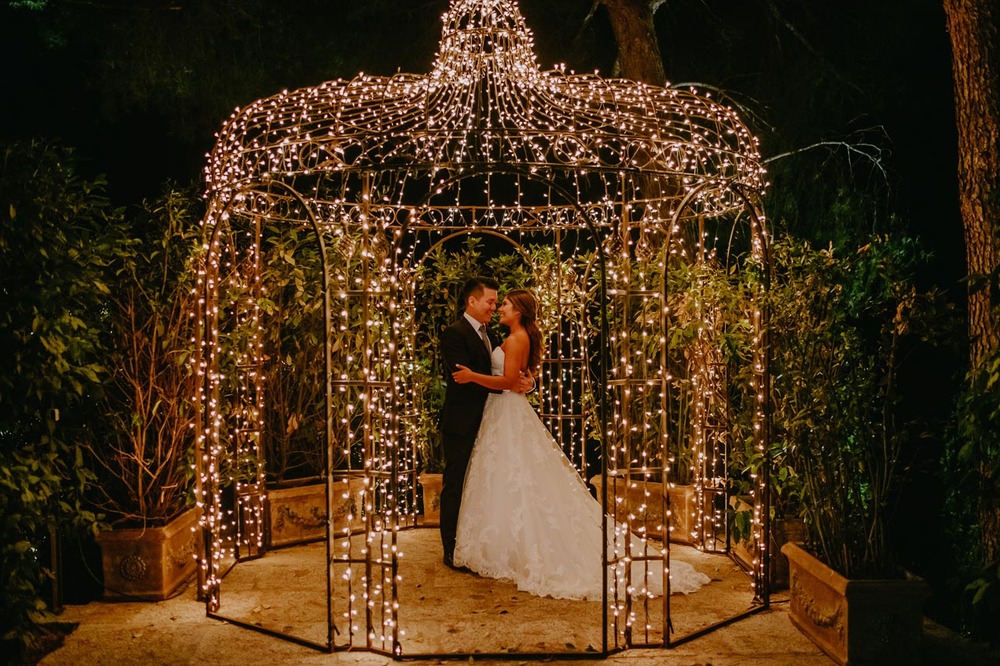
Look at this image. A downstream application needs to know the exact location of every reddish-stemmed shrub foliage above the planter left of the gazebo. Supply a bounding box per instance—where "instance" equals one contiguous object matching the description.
[87,184,201,525]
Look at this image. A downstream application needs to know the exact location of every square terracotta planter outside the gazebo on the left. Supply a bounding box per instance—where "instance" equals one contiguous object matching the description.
[97,509,202,601]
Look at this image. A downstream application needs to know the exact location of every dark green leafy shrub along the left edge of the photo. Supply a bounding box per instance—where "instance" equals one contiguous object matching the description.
[0,142,107,654]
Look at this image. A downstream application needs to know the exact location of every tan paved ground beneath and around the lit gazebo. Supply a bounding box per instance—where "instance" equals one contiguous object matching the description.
[40,530,1000,666]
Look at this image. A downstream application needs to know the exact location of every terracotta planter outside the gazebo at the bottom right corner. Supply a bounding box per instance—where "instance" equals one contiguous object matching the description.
[781,543,929,664]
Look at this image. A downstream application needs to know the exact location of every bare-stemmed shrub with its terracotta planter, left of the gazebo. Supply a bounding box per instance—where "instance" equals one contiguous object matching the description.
[87,189,201,599]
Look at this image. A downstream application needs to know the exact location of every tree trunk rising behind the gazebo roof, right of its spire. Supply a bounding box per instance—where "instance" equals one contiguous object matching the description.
[600,0,667,86]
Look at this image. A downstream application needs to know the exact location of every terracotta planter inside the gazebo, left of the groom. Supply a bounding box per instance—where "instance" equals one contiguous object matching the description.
[267,477,365,548]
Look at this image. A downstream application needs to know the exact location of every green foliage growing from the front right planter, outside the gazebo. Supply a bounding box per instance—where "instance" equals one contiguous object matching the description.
[768,236,943,578]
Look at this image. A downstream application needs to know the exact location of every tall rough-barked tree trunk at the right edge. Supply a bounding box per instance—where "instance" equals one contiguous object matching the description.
[944,0,1000,562]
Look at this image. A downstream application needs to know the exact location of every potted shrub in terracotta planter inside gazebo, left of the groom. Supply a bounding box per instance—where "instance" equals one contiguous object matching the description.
[258,226,364,548]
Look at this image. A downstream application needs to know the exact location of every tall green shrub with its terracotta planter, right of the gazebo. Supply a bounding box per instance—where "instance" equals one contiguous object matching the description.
[771,238,948,664]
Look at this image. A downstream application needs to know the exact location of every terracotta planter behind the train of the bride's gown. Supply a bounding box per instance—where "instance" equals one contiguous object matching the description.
[590,476,697,543]
